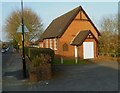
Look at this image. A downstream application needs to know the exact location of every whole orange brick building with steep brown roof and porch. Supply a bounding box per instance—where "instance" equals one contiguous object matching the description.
[39,6,100,59]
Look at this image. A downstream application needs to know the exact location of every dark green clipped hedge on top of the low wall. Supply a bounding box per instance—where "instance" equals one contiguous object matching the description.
[25,47,54,67]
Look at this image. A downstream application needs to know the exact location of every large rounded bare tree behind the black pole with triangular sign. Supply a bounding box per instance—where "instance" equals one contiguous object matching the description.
[5,8,43,43]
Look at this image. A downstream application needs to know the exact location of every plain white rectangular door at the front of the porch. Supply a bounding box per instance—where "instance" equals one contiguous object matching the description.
[83,42,94,59]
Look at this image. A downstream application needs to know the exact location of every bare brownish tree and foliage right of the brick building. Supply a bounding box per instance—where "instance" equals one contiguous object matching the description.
[99,16,118,56]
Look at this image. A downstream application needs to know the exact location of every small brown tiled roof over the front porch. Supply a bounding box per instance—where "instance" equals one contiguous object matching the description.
[71,30,90,46]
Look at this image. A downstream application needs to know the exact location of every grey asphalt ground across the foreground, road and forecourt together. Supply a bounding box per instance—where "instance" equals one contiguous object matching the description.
[2,47,118,91]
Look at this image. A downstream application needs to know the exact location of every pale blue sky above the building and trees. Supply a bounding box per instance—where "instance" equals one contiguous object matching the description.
[0,2,118,40]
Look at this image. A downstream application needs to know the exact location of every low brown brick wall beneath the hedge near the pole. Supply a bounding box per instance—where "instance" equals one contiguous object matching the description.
[28,64,52,82]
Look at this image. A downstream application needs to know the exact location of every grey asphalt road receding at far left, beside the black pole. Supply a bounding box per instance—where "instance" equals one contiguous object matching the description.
[2,47,23,90]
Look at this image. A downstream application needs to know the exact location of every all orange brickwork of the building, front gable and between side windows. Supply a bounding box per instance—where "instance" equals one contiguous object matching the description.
[39,13,98,58]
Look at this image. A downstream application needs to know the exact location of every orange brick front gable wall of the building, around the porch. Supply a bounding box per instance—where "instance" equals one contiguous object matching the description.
[59,14,98,58]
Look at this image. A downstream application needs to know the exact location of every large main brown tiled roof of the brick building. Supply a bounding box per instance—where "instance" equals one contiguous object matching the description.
[38,6,100,40]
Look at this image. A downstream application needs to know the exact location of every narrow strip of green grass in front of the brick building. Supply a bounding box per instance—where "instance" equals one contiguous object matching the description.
[53,58,92,65]
